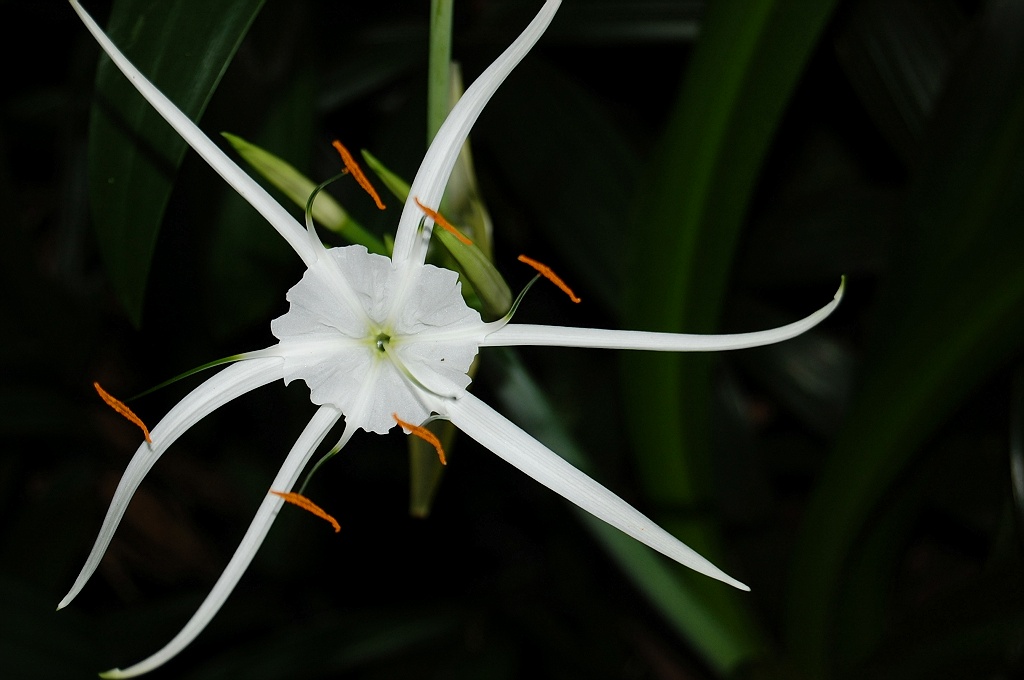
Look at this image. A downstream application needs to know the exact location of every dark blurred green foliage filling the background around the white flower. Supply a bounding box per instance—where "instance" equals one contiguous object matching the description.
[0,0,1024,680]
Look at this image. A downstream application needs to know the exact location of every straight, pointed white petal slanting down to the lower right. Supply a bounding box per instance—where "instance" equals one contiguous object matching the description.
[442,392,750,590]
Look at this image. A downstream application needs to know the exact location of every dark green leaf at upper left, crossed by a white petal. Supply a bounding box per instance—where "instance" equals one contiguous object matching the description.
[89,0,264,326]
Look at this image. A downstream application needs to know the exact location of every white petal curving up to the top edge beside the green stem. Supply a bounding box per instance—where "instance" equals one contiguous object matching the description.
[392,0,561,266]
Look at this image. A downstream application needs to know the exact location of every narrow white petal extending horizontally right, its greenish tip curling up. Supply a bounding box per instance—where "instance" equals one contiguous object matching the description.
[480,283,845,352]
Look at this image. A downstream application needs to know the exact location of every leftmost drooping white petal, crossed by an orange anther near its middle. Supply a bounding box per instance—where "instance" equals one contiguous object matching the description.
[57,358,284,609]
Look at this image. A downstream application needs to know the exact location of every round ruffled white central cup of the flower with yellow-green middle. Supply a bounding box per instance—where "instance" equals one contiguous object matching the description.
[267,246,487,434]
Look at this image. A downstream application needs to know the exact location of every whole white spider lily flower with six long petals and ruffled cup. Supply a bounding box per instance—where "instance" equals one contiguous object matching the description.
[68,0,843,678]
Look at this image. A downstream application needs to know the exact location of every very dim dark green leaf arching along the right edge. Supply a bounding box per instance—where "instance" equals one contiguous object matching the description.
[787,1,1024,678]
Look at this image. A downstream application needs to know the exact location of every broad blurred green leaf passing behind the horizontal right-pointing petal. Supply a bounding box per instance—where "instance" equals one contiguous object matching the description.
[624,0,836,670]
